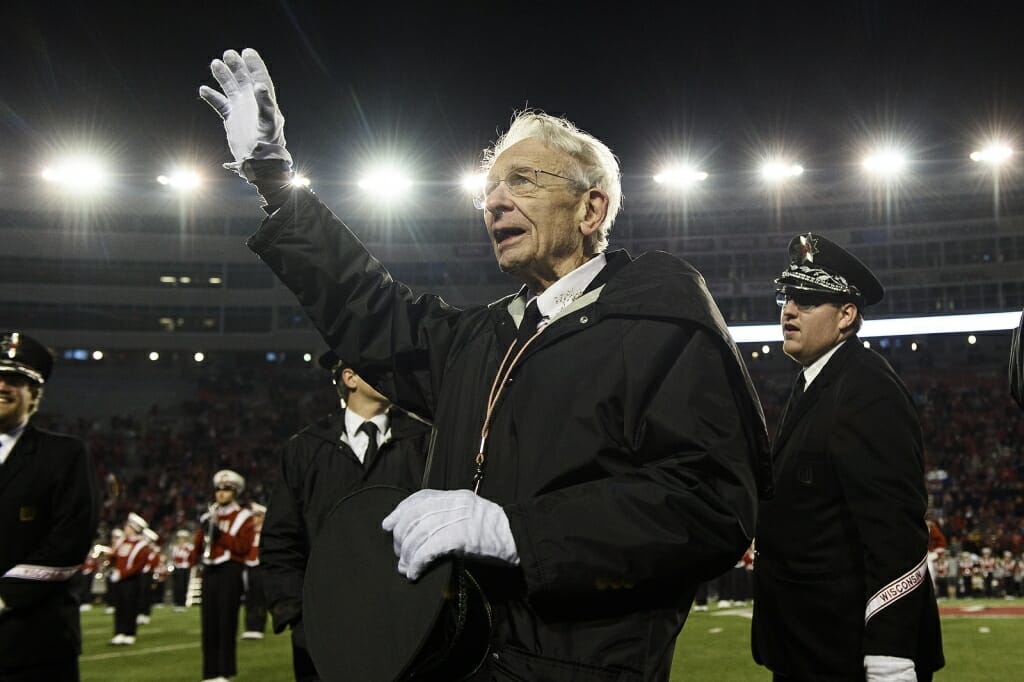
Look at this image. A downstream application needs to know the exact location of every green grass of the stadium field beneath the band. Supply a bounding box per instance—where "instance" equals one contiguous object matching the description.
[81,600,1024,682]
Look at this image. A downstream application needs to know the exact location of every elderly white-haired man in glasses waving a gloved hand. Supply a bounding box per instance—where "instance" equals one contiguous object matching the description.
[200,50,770,682]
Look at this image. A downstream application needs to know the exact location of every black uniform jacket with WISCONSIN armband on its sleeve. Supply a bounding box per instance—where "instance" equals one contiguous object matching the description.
[752,337,943,681]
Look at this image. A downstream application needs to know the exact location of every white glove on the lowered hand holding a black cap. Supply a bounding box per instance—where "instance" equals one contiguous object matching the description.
[381,491,519,581]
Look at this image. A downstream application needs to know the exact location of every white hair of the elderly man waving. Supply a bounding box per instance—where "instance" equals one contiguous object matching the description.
[481,110,623,255]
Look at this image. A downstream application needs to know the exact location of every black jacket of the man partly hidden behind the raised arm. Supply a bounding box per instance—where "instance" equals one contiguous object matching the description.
[259,408,431,632]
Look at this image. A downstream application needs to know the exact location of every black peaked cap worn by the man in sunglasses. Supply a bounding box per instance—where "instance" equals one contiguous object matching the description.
[775,232,885,306]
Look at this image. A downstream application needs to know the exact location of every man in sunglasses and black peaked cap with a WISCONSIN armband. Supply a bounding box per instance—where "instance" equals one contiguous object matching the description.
[753,232,943,682]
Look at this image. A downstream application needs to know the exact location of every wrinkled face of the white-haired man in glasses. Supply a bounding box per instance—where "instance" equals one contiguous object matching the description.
[483,138,587,293]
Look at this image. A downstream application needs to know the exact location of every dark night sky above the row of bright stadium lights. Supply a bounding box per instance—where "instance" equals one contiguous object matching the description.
[0,0,1024,182]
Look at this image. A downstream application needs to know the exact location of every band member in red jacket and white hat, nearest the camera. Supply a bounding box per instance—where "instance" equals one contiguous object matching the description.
[195,469,254,680]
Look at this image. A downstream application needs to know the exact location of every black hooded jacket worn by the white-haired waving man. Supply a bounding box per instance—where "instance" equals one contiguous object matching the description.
[249,190,770,682]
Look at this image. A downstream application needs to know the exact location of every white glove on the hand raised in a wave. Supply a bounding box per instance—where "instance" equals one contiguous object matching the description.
[199,47,292,177]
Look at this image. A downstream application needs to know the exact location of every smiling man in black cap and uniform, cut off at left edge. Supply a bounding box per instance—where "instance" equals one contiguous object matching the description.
[0,331,99,682]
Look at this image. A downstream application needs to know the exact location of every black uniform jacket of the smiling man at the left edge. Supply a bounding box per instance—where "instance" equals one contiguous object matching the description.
[0,423,99,677]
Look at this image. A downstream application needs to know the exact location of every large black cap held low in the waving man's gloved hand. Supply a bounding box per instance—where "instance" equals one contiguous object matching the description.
[302,485,490,682]
